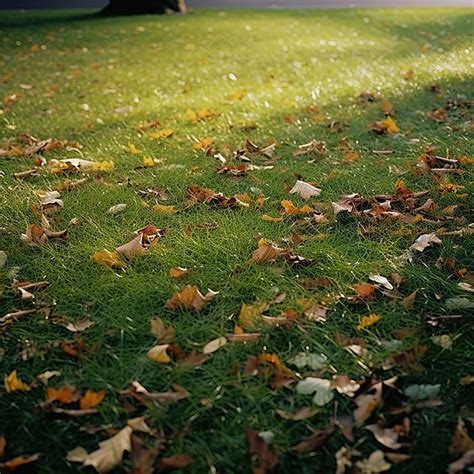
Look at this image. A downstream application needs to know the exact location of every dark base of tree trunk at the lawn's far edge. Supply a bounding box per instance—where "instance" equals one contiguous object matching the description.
[101,0,188,15]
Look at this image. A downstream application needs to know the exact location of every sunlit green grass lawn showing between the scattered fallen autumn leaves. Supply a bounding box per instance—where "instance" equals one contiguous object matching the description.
[0,9,474,473]
